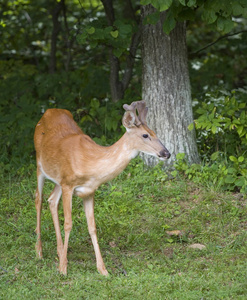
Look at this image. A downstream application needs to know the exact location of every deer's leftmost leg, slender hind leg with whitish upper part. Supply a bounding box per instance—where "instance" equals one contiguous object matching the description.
[35,168,45,258]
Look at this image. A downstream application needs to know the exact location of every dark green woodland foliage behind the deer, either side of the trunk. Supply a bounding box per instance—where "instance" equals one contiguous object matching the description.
[0,0,247,175]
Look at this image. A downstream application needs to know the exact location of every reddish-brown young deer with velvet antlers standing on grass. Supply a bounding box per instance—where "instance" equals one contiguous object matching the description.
[34,101,170,275]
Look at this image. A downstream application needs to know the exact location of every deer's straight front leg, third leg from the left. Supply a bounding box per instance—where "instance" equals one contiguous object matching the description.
[59,187,73,275]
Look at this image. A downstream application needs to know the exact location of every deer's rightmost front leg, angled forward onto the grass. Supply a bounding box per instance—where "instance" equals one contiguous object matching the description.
[83,195,108,275]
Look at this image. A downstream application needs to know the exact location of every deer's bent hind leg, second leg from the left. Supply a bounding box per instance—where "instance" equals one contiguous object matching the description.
[48,184,63,258]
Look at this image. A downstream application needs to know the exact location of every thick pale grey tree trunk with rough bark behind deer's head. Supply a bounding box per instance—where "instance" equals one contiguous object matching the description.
[142,5,199,166]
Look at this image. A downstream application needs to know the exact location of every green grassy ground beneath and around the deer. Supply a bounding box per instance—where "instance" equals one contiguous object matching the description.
[0,162,247,300]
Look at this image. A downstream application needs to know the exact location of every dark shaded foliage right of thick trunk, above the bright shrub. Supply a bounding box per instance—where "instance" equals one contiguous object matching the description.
[187,18,247,92]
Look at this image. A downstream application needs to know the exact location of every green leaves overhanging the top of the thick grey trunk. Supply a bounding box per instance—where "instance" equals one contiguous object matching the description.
[141,0,247,34]
